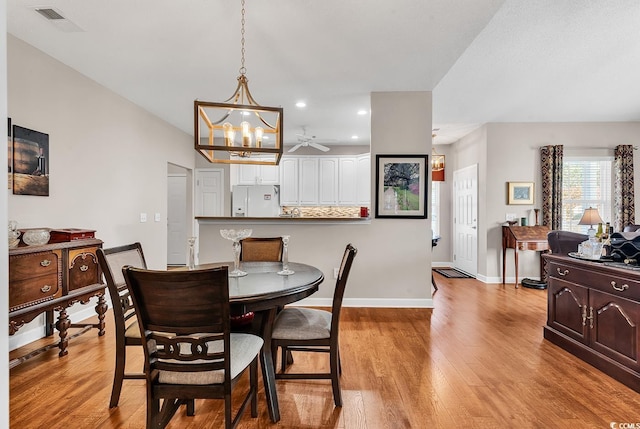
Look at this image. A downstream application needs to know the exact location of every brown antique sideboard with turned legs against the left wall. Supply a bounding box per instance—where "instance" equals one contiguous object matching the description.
[9,238,107,366]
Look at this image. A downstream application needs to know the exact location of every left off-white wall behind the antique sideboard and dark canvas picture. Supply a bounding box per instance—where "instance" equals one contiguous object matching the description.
[7,36,195,348]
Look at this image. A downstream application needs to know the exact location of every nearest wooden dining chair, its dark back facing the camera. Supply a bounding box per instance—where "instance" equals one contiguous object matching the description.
[122,266,263,429]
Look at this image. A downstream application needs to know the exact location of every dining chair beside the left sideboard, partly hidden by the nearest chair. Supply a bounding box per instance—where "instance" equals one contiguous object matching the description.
[97,243,147,408]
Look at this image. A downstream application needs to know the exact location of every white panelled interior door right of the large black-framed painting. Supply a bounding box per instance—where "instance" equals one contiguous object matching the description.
[453,164,478,277]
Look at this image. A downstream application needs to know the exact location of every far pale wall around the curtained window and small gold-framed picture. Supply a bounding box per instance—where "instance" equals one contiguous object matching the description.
[447,122,640,283]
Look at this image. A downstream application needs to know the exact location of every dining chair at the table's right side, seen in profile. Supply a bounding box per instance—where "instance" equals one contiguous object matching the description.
[271,244,358,407]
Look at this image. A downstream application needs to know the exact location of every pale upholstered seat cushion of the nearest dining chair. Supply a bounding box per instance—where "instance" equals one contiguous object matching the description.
[158,333,263,385]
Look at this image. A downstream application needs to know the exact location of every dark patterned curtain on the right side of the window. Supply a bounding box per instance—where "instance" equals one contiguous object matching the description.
[613,145,636,231]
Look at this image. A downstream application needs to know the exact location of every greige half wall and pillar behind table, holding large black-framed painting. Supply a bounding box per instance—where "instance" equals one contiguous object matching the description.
[199,92,432,307]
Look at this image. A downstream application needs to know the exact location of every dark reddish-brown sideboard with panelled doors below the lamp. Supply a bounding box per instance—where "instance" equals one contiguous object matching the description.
[543,254,640,392]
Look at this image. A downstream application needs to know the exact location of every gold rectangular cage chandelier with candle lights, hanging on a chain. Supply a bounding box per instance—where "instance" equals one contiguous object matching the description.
[193,0,283,165]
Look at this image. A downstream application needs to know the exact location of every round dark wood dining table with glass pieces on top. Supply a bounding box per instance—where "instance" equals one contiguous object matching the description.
[195,262,324,423]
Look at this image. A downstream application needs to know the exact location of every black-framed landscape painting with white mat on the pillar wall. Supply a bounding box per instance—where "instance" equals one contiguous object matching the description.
[376,155,428,219]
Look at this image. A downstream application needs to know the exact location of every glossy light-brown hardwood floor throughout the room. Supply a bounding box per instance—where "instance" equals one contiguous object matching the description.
[10,274,640,429]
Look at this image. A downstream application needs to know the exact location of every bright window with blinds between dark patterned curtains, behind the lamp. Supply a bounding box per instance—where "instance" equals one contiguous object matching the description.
[562,157,613,234]
